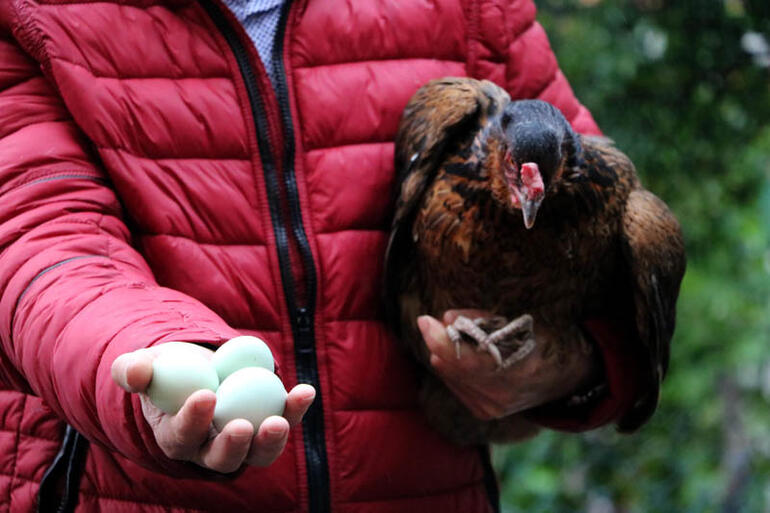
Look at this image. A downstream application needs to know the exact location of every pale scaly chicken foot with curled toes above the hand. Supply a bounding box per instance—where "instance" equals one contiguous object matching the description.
[446,314,535,369]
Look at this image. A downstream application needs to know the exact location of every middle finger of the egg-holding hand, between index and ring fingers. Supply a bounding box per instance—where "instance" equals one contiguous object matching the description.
[194,419,254,474]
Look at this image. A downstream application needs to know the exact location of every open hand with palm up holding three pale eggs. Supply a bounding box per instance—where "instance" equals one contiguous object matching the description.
[111,344,315,473]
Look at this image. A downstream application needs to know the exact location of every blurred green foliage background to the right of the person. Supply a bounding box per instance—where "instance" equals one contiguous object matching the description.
[494,0,770,513]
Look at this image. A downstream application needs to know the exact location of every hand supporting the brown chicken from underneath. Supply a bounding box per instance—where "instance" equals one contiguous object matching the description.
[417,310,598,420]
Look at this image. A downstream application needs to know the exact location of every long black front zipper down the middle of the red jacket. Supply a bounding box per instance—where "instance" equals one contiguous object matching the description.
[200,0,331,513]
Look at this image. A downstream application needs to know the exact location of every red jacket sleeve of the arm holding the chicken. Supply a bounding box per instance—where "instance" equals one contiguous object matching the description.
[488,0,644,431]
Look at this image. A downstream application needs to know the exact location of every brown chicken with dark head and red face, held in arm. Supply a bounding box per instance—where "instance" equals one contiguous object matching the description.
[385,78,685,444]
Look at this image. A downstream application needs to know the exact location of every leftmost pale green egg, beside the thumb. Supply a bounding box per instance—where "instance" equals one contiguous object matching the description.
[147,342,219,415]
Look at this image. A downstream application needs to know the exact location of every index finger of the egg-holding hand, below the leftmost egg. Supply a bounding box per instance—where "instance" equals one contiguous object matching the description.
[155,390,217,460]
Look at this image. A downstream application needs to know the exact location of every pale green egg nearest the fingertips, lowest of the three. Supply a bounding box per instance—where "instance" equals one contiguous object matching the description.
[214,367,287,432]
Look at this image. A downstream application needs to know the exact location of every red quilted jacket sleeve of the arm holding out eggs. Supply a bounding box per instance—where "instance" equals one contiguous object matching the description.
[0,26,237,476]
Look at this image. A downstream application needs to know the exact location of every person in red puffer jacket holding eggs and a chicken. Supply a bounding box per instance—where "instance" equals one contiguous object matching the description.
[0,0,650,513]
